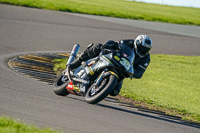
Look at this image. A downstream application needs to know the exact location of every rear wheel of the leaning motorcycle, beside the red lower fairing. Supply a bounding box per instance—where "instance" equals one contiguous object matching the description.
[53,73,69,96]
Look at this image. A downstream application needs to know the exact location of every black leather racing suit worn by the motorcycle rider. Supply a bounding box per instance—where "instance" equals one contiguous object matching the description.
[79,39,150,96]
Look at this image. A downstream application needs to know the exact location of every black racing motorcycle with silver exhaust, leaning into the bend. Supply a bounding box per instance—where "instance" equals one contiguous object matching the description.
[53,44,135,104]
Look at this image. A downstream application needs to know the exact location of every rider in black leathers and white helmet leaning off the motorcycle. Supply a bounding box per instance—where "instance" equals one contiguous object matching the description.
[68,35,152,96]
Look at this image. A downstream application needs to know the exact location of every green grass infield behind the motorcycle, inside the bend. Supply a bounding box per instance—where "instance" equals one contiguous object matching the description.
[54,55,200,122]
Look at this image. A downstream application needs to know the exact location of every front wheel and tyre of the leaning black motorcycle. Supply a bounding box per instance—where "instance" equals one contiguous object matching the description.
[85,74,118,104]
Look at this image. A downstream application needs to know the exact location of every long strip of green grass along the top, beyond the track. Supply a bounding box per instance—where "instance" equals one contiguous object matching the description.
[0,0,200,25]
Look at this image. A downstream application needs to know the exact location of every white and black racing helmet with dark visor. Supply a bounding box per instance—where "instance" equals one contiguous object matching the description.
[134,35,152,58]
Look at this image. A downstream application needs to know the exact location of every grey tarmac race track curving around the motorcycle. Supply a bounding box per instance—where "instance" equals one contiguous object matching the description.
[0,5,200,133]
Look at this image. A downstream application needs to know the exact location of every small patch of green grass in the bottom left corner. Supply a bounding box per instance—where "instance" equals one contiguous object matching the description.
[0,117,61,133]
